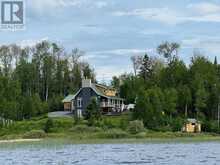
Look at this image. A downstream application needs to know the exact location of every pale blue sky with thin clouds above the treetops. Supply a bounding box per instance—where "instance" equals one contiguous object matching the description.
[0,0,220,81]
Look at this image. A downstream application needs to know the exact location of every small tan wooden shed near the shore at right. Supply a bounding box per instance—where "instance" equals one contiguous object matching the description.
[182,119,201,133]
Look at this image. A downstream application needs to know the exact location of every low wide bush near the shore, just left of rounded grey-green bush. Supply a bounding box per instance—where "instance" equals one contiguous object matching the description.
[99,129,128,139]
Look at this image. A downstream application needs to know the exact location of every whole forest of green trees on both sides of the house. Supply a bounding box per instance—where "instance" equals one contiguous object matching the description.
[0,41,220,132]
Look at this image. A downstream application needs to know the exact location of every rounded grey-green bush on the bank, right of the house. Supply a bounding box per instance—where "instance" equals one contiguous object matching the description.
[128,120,144,134]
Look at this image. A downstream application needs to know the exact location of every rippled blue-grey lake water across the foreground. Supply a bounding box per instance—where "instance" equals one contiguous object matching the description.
[0,142,220,165]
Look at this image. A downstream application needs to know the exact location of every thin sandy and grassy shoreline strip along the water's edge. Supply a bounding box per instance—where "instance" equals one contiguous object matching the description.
[0,136,220,144]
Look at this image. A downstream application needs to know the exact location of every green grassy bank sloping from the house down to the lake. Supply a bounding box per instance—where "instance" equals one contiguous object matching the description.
[0,115,220,143]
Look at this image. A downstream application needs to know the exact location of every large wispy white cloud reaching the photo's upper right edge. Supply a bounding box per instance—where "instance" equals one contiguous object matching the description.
[113,3,220,25]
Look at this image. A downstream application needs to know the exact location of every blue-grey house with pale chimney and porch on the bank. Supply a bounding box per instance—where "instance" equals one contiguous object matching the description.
[63,79,124,117]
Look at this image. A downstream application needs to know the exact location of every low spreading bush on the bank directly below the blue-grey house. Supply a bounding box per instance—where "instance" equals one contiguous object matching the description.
[70,125,102,134]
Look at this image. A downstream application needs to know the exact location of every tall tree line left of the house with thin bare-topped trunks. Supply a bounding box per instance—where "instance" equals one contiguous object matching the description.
[0,41,95,120]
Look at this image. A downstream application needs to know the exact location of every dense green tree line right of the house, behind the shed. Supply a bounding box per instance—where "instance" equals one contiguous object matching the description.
[112,42,220,131]
